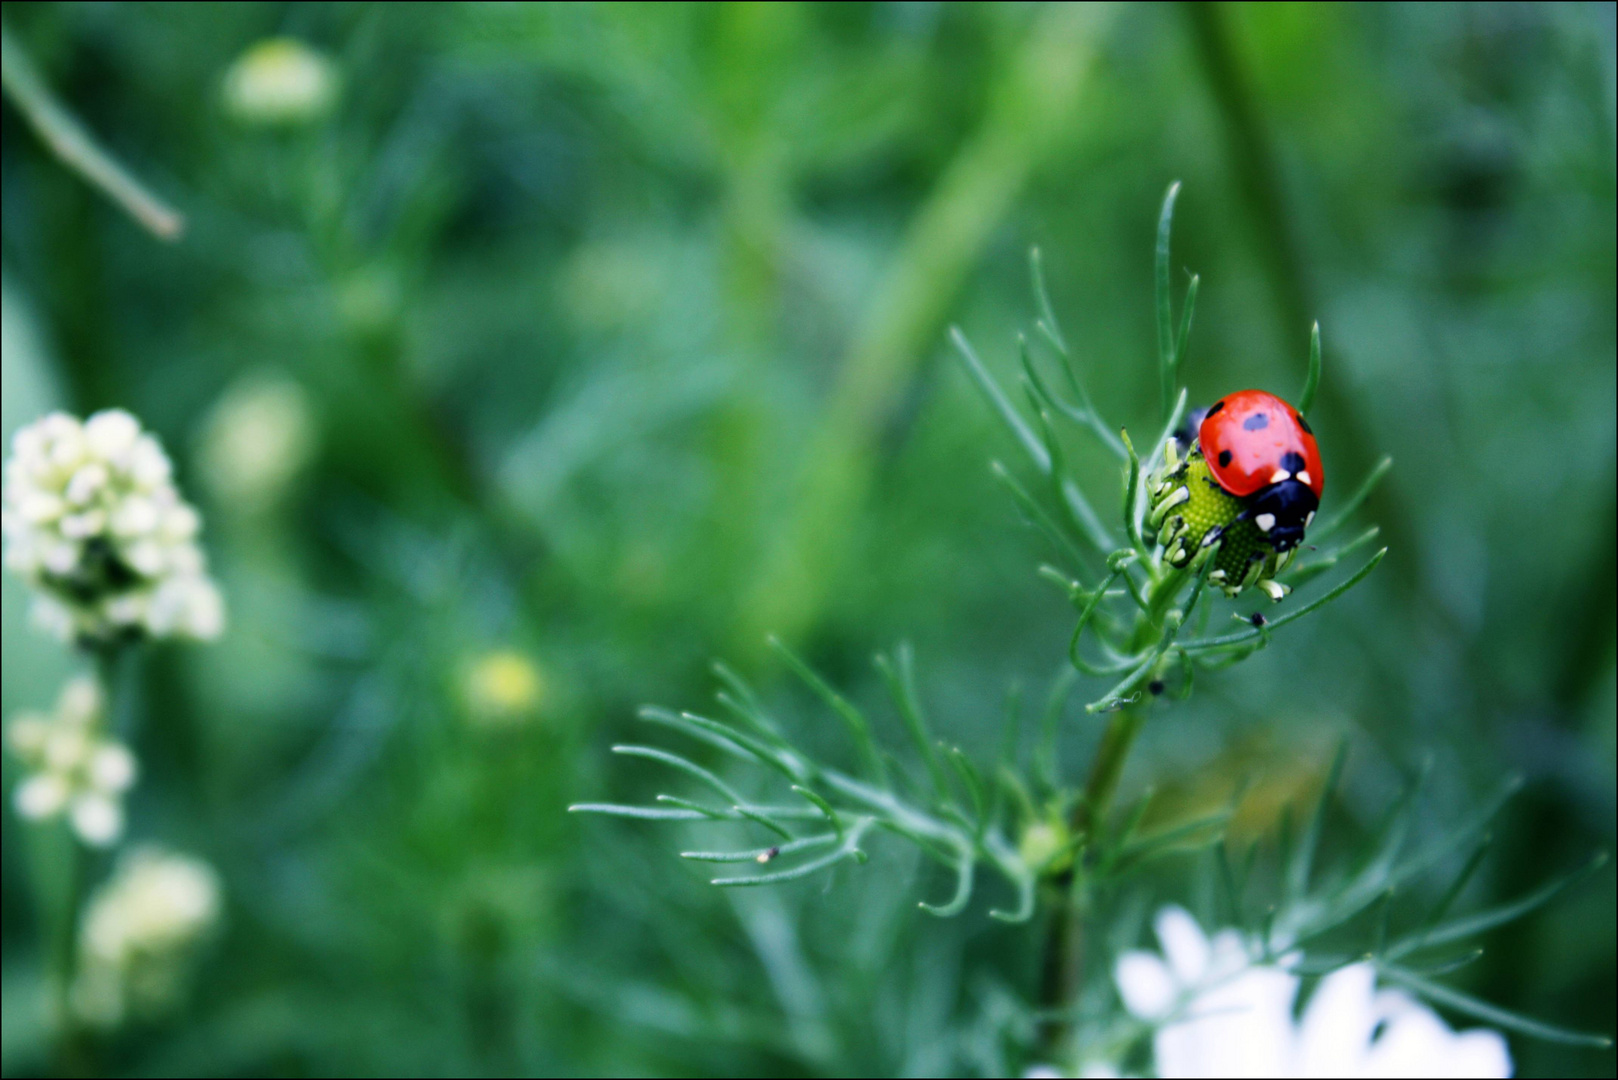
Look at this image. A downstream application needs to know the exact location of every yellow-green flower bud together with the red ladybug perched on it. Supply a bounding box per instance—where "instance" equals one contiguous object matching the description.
[1149,390,1325,599]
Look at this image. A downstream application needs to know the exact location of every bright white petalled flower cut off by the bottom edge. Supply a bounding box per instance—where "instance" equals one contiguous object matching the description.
[1115,907,1511,1077]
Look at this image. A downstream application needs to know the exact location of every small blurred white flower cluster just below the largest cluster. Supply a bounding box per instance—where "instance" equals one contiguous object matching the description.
[5,675,136,847]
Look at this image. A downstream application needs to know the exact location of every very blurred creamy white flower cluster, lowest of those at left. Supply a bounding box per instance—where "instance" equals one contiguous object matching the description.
[73,847,220,1028]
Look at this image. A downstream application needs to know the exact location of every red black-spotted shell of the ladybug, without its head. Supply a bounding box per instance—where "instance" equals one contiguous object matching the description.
[1197,390,1325,499]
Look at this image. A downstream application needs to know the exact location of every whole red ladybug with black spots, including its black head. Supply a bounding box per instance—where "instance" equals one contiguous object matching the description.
[1197,390,1325,551]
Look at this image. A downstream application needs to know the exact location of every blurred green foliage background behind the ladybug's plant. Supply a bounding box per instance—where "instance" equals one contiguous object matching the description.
[0,3,1618,1075]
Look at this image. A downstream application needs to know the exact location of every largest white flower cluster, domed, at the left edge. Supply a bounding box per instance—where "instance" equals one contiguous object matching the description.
[0,410,225,643]
